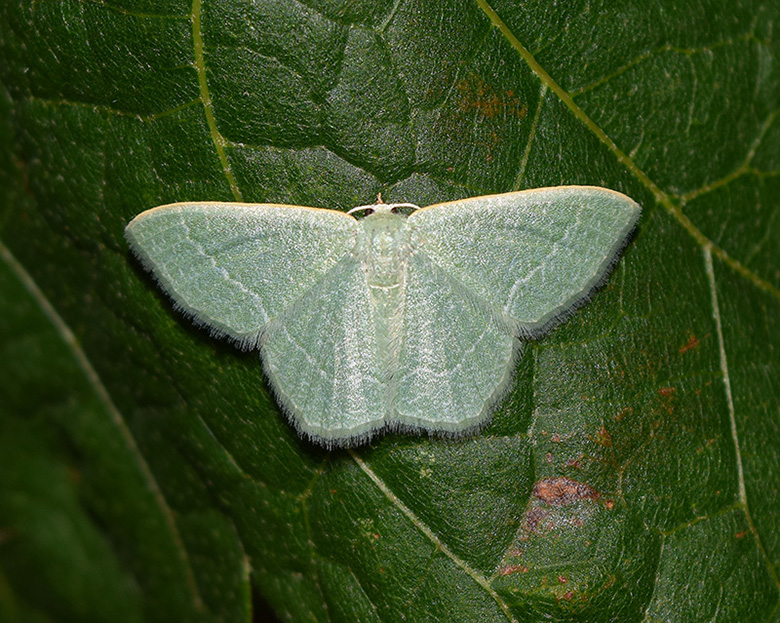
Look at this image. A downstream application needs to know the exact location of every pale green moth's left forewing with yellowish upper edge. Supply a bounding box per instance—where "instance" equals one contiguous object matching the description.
[125,202,358,348]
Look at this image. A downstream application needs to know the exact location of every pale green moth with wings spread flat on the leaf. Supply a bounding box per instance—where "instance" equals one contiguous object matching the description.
[125,186,640,447]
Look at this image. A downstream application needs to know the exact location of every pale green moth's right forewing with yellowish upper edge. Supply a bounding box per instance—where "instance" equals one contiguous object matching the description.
[409,186,640,337]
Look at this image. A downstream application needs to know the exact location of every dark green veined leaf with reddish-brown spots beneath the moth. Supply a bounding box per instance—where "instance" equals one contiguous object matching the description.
[0,0,780,623]
